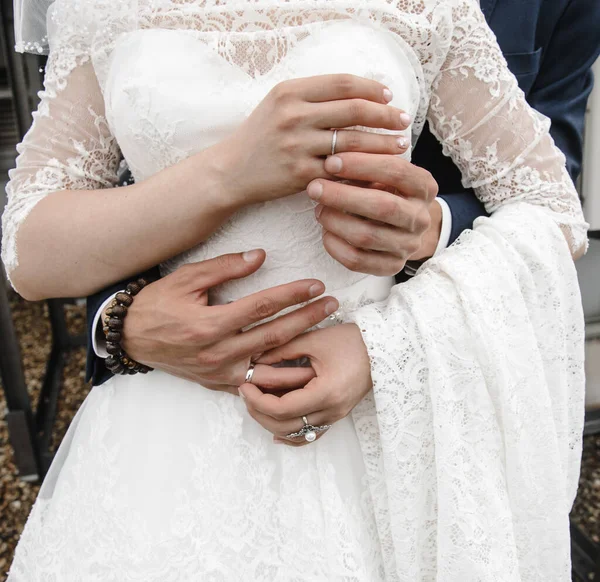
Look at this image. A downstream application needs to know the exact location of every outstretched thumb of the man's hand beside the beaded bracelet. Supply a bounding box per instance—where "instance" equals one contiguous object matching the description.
[186,249,267,290]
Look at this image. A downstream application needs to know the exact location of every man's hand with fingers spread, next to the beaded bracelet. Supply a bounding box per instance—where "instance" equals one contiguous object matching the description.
[116,250,339,394]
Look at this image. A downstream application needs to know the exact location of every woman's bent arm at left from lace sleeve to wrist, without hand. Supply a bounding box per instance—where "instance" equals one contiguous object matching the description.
[3,56,239,299]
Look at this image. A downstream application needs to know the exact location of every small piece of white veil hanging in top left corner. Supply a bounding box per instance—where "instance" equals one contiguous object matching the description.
[14,0,54,54]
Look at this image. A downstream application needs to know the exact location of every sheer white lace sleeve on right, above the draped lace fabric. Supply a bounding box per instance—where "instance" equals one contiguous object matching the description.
[428,0,587,256]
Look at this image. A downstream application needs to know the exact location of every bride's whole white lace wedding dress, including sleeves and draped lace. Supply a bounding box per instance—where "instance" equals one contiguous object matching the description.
[3,0,586,582]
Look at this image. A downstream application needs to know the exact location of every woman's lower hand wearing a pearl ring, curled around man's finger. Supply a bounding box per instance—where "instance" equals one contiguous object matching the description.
[239,324,372,446]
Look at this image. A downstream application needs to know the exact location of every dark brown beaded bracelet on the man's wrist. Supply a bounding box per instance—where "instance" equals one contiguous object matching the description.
[103,279,154,374]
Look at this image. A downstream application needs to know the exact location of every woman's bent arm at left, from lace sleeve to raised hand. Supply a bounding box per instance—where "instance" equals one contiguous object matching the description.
[3,54,407,299]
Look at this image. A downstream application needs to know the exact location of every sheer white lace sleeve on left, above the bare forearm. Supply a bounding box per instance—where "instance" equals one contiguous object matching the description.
[2,52,120,277]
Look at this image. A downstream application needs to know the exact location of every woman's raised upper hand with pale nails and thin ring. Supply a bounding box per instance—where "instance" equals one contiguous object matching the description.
[219,75,411,206]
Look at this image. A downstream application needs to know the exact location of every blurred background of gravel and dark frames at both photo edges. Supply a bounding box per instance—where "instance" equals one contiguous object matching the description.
[0,0,600,581]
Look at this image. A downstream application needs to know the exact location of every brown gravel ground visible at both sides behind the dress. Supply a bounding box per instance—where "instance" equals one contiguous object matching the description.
[0,293,600,581]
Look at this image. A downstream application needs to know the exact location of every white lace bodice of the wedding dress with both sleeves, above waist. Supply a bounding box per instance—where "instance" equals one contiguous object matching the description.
[3,0,585,292]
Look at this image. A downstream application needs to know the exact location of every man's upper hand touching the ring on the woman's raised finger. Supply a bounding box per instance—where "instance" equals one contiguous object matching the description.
[307,152,441,275]
